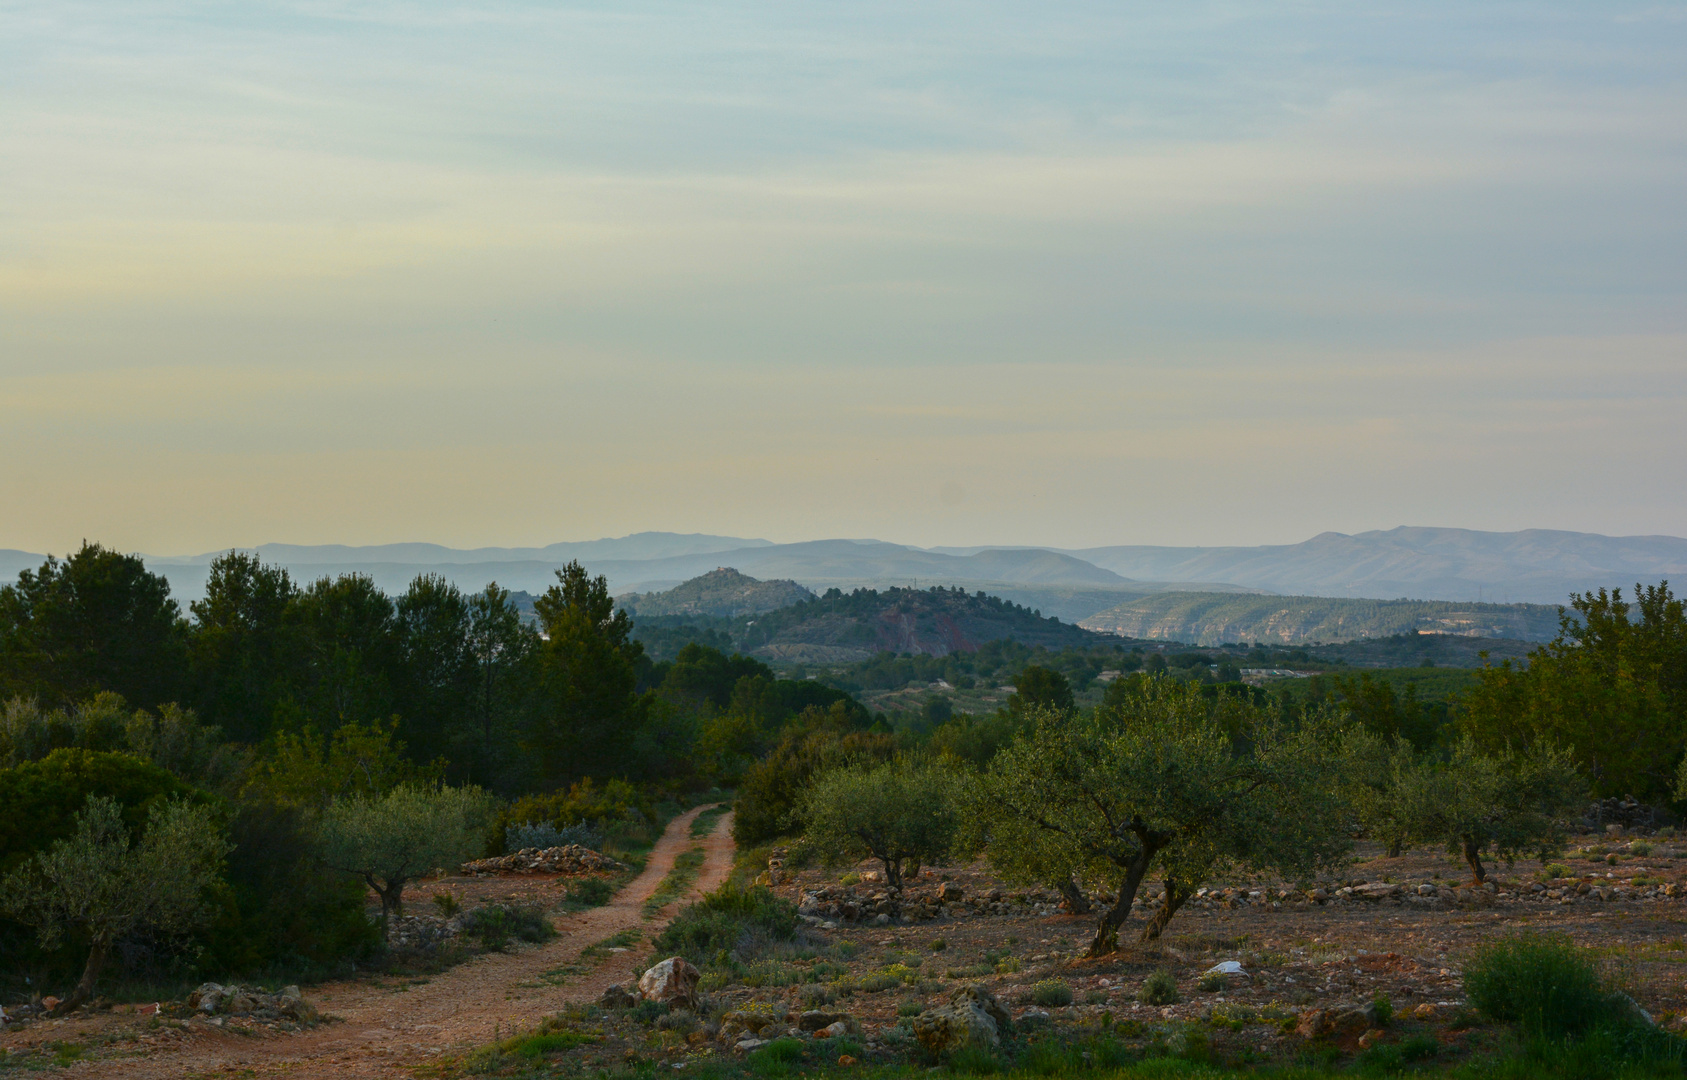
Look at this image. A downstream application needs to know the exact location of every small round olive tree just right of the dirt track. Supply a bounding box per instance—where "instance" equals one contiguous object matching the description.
[796,761,958,889]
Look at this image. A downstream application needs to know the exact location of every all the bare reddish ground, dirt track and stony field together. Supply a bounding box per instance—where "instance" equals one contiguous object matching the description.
[0,818,1687,1077]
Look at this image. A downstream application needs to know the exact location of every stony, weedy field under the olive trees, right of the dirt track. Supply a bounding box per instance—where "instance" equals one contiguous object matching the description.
[431,834,1687,1073]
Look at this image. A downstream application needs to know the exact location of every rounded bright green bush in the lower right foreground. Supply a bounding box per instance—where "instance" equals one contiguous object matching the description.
[1464,933,1621,1040]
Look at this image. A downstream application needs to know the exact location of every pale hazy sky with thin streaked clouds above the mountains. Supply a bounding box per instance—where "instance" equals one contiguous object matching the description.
[0,0,1687,554]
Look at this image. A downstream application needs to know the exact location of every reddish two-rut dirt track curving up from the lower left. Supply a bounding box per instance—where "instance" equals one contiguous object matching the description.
[42,807,732,1080]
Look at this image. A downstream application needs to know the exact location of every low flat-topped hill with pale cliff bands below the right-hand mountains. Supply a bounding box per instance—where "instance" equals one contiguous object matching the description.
[1081,592,1559,645]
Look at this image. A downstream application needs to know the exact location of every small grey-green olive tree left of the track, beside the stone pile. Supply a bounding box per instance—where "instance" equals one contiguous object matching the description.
[319,785,493,925]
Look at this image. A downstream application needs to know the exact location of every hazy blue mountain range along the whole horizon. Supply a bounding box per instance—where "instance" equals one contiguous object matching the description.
[0,528,1687,621]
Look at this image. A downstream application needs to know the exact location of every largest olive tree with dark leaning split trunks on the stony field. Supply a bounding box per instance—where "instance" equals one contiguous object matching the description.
[968,677,1351,955]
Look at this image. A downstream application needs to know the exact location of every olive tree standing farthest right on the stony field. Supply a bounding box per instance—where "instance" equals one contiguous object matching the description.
[1385,736,1587,884]
